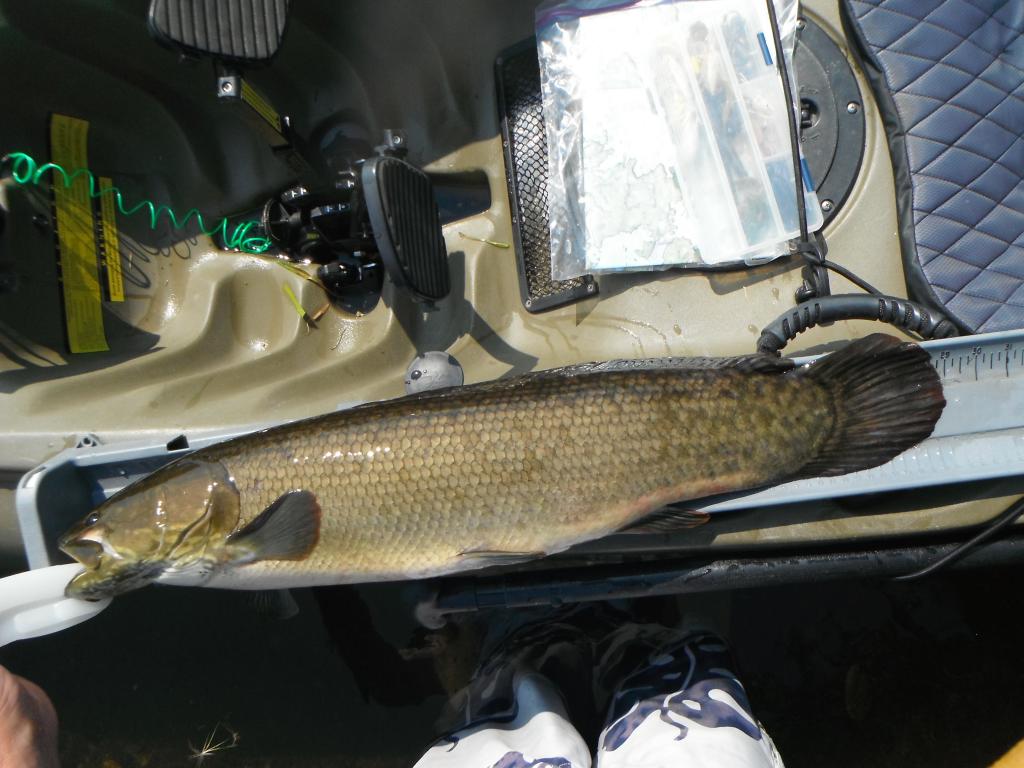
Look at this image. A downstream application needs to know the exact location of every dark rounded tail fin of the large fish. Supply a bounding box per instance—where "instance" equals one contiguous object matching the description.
[788,334,946,477]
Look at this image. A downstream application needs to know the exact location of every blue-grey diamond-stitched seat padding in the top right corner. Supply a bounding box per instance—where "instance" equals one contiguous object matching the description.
[847,0,1024,332]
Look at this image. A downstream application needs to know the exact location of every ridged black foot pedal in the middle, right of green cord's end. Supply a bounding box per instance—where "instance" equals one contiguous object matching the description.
[361,157,452,302]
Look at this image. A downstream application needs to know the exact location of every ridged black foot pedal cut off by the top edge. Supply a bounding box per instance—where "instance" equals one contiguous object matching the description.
[148,0,289,62]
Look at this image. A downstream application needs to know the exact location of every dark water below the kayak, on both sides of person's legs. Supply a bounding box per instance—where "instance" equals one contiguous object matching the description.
[0,569,1024,768]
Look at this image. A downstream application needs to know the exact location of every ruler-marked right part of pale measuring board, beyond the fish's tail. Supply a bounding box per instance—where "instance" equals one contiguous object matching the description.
[694,331,1024,513]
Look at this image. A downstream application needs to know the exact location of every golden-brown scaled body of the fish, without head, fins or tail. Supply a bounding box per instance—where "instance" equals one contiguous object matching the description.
[203,371,830,583]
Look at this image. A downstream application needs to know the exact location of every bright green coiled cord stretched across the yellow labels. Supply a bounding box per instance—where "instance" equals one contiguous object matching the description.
[3,152,270,254]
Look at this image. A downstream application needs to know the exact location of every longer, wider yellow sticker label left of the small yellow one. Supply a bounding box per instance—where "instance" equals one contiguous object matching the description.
[50,115,110,352]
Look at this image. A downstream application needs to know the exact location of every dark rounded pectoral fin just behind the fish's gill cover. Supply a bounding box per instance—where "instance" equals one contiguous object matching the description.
[227,490,321,562]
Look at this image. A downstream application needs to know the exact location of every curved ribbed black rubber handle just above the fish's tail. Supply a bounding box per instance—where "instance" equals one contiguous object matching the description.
[758,293,957,354]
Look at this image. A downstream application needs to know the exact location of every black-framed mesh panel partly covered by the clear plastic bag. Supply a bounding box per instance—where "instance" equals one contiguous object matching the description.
[495,38,597,312]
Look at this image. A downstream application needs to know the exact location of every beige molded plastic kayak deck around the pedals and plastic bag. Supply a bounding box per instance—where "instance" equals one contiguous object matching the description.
[0,0,1011,555]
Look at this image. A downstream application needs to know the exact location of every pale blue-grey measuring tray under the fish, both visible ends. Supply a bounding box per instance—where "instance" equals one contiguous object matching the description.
[15,331,1024,568]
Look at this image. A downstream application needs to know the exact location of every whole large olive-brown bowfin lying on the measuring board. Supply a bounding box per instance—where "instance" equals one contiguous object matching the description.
[60,335,945,597]
